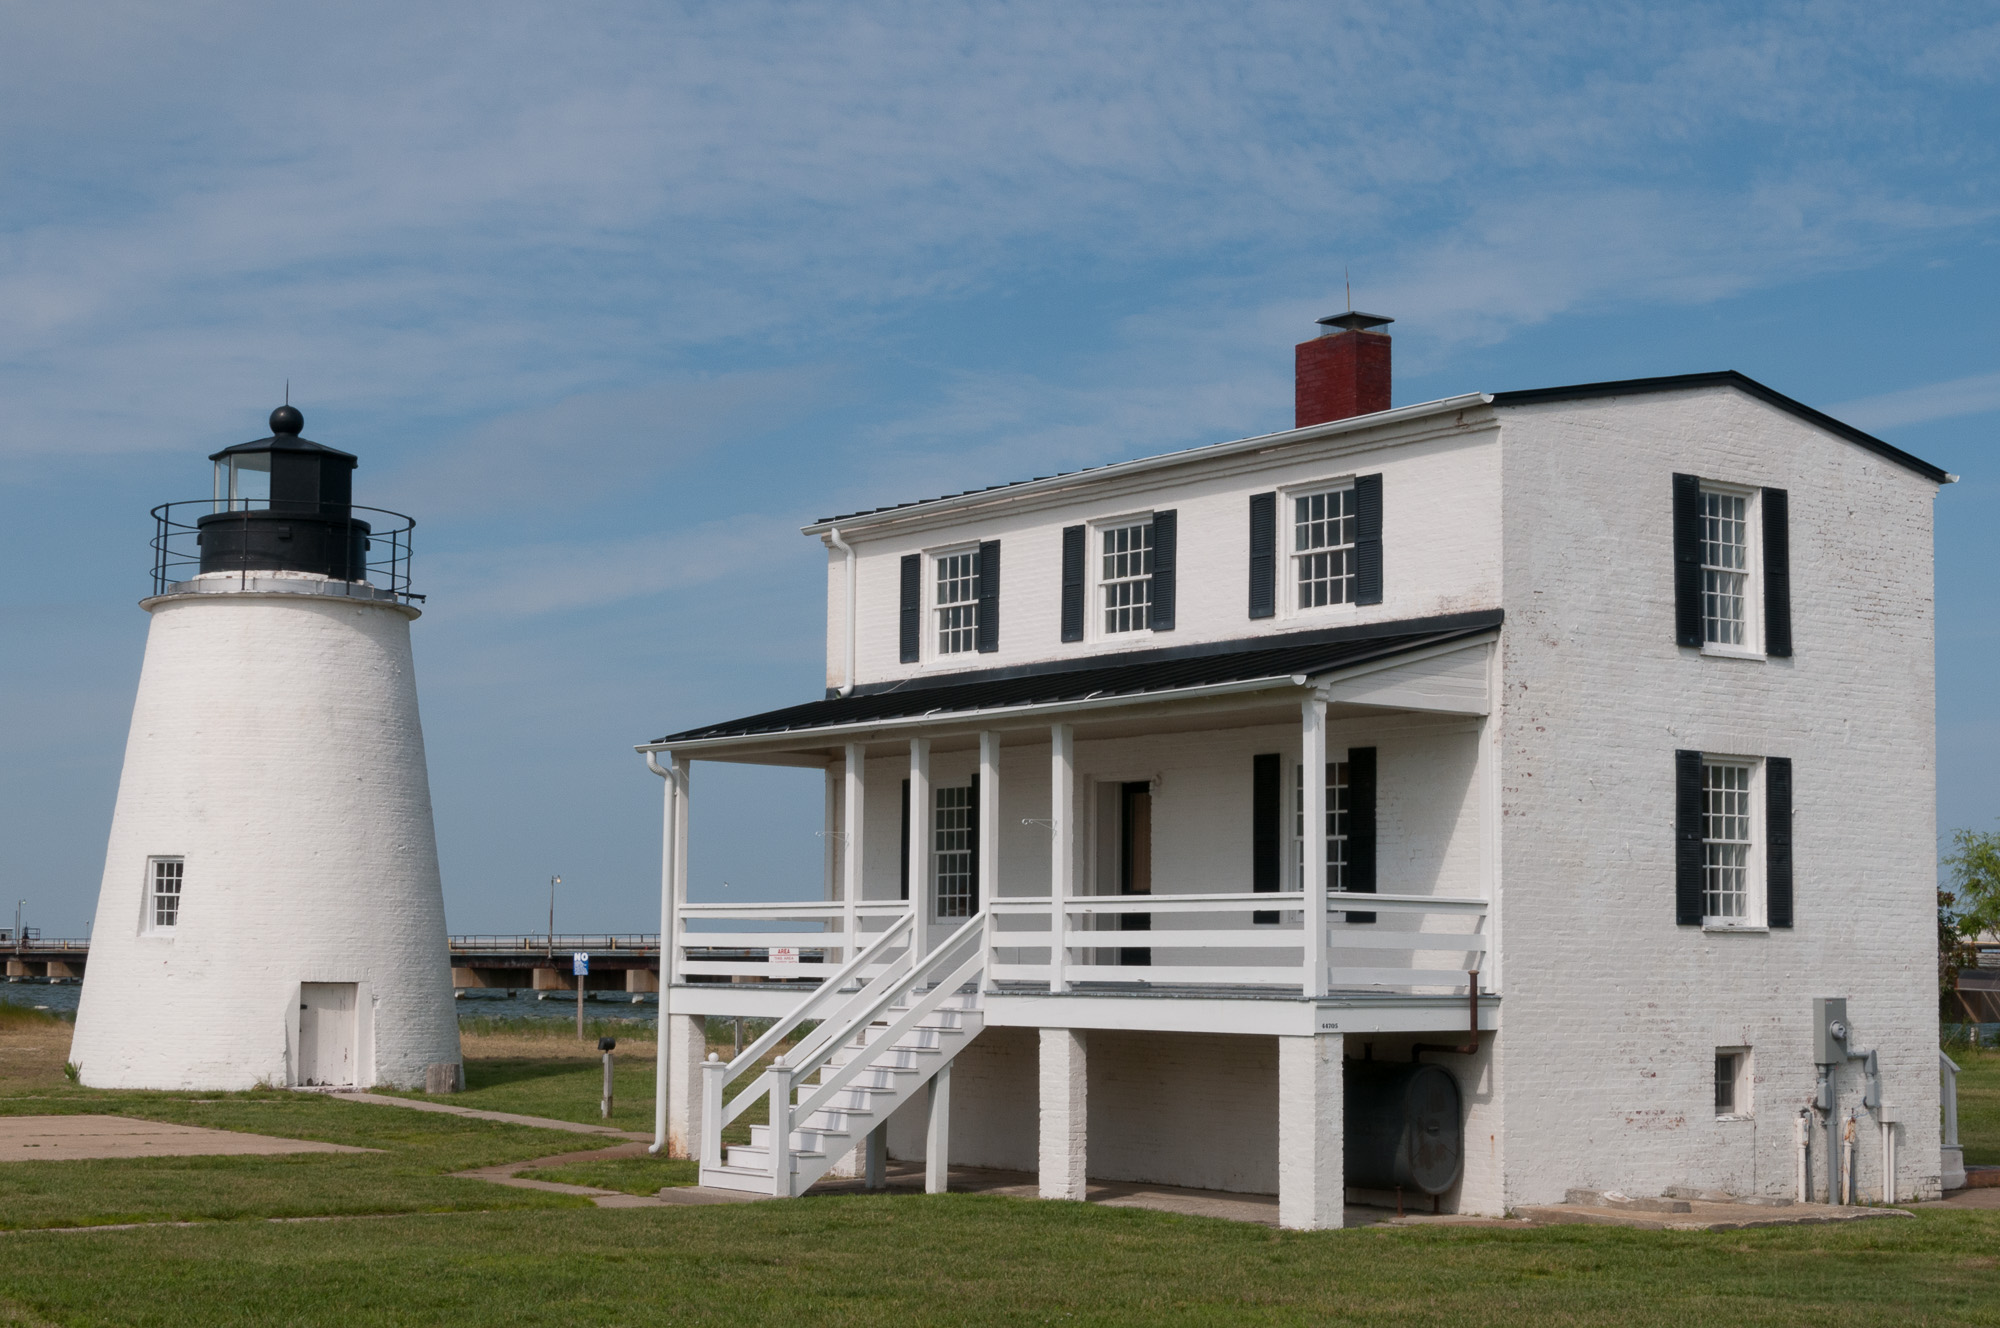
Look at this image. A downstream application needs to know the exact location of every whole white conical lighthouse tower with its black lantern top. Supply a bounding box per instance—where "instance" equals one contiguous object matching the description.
[70,406,462,1090]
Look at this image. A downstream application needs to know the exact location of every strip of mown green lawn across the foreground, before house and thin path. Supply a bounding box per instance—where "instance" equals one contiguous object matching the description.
[0,1196,2000,1328]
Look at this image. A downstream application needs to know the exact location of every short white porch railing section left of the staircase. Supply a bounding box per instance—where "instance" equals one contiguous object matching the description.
[674,900,910,982]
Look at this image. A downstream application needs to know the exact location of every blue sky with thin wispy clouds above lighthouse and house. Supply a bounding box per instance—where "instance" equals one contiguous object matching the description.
[0,2,2000,934]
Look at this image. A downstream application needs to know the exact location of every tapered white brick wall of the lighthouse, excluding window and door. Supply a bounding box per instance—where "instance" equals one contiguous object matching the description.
[70,594,458,1090]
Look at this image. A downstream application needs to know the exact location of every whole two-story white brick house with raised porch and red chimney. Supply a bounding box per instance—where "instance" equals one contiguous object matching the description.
[640,314,1952,1228]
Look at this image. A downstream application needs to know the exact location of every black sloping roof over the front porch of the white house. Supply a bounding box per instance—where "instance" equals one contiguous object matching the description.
[648,608,1502,746]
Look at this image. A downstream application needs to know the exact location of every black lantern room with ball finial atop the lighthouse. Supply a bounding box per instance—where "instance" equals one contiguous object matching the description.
[194,406,368,580]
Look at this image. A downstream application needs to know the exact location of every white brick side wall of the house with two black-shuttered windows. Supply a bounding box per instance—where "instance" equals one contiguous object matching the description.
[1500,390,1938,1204]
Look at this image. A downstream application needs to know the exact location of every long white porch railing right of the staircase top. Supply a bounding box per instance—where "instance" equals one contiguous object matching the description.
[988,890,1488,994]
